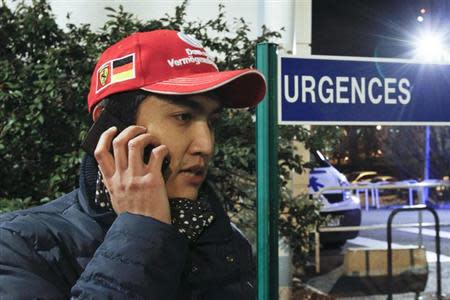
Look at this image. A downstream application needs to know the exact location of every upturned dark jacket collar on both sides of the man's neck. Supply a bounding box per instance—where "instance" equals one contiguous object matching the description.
[78,154,233,244]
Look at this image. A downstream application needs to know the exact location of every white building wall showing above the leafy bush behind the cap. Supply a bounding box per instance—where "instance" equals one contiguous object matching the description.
[6,0,298,50]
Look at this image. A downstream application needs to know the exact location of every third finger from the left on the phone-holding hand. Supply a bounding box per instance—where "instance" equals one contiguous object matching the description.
[128,133,160,172]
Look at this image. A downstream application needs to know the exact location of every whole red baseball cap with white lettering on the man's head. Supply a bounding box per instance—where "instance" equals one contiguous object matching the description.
[88,30,266,112]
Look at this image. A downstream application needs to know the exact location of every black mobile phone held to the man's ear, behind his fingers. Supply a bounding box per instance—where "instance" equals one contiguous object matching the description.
[81,109,170,172]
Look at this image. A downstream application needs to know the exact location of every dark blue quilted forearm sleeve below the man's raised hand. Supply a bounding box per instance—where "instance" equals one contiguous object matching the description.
[71,213,187,300]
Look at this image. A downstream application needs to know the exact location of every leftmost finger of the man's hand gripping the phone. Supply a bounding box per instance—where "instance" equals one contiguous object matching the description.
[94,127,117,177]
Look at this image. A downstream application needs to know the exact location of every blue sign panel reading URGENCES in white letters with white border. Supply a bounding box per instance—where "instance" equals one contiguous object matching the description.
[278,56,450,125]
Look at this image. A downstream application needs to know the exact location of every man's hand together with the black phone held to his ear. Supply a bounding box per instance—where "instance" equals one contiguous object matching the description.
[82,111,171,224]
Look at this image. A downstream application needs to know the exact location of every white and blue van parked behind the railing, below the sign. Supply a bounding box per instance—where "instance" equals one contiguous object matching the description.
[308,151,361,248]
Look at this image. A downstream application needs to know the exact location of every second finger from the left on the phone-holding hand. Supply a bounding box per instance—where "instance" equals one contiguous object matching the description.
[113,126,147,171]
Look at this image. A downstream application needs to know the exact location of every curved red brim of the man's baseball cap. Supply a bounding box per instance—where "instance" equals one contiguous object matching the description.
[141,69,266,108]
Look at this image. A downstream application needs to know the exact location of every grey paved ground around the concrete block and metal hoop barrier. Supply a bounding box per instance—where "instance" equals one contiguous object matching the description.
[300,209,450,299]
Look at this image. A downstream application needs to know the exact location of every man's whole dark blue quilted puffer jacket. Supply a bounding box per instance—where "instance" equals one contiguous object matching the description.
[0,156,255,300]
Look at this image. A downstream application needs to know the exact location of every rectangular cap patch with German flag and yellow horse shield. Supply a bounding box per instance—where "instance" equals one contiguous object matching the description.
[96,53,136,93]
